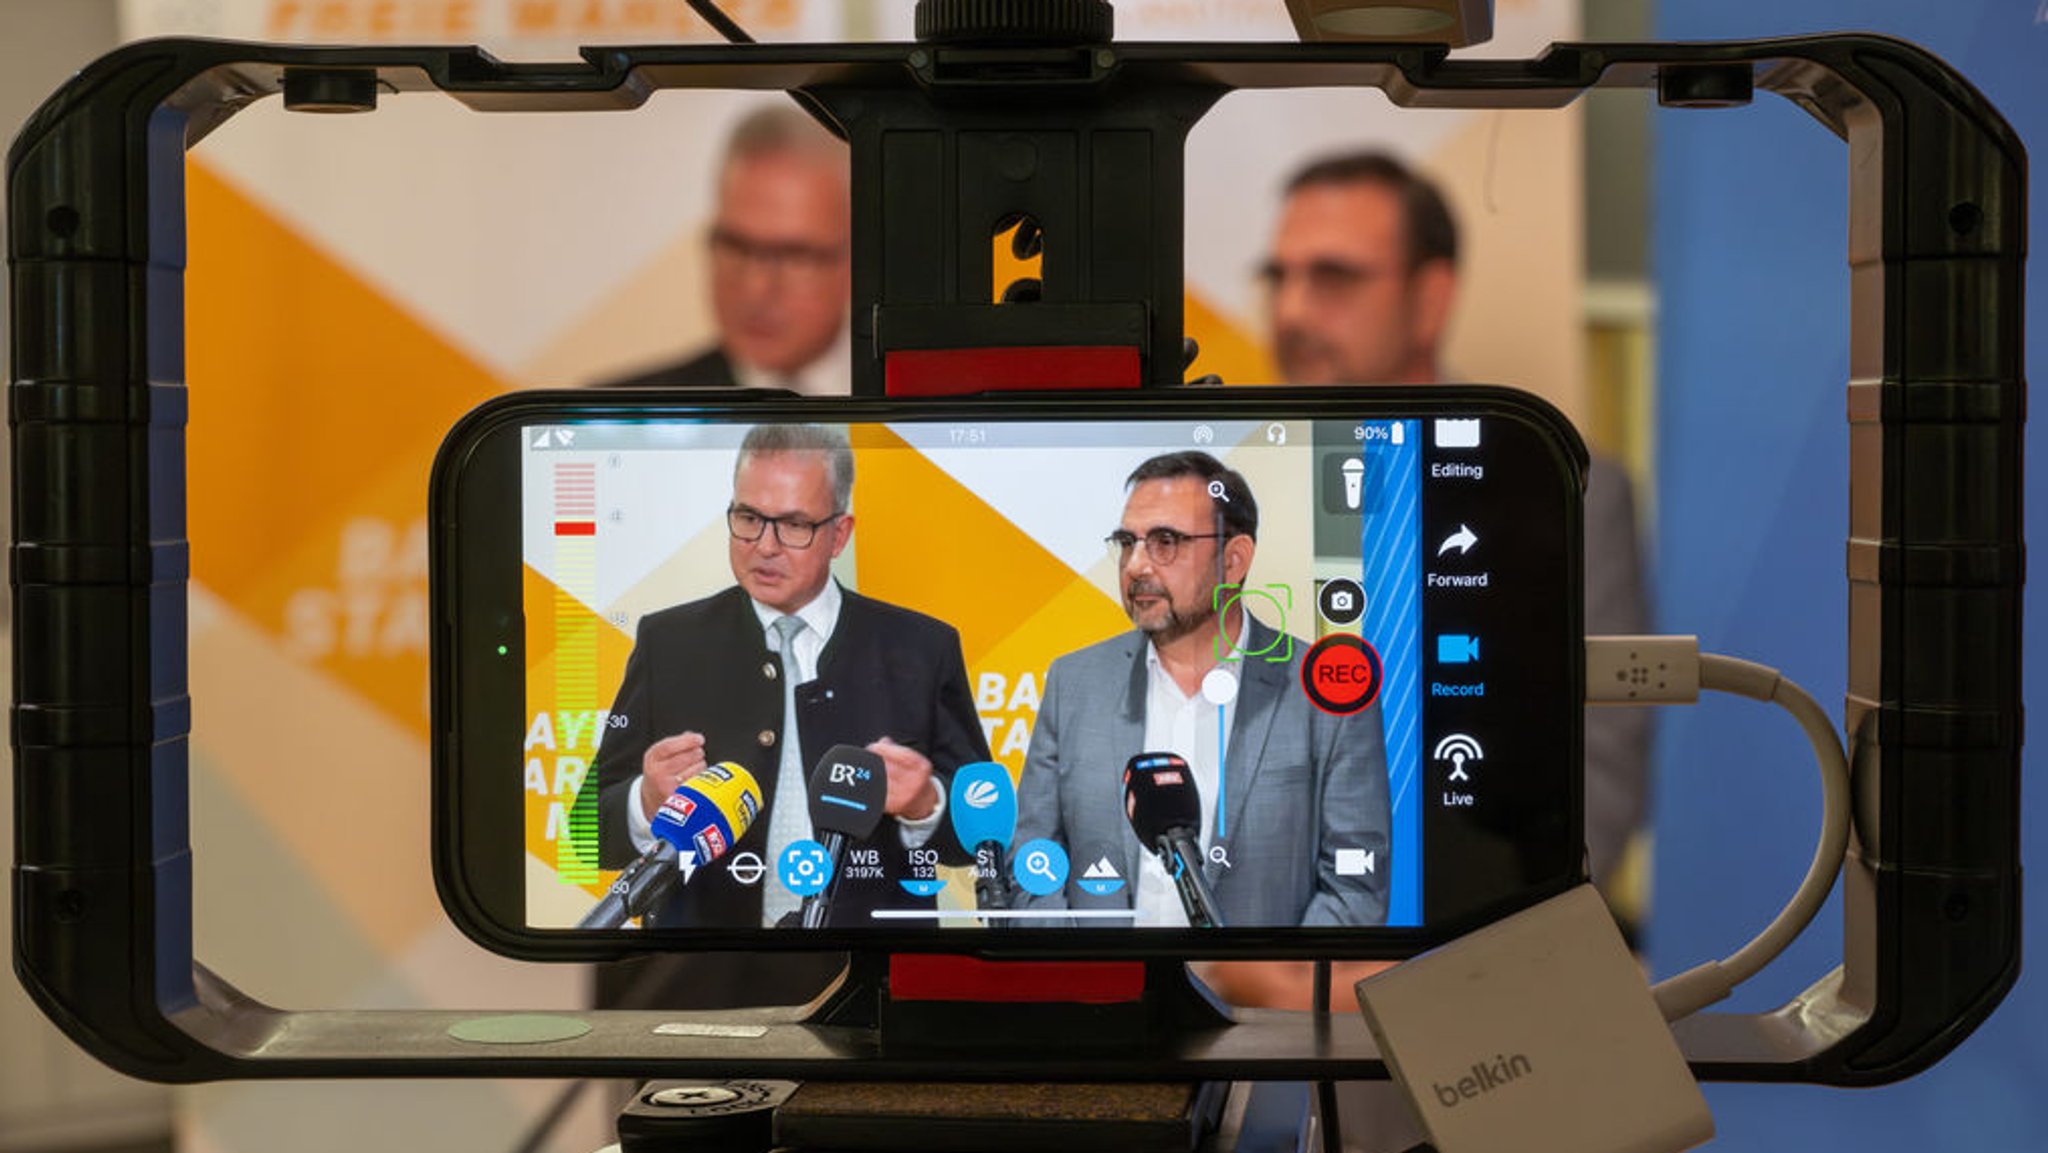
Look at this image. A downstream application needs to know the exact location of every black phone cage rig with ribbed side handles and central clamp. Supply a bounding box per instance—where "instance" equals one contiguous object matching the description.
[8,0,2025,1130]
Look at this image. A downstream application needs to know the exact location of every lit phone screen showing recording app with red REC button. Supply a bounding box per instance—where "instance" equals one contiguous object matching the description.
[508,416,1575,932]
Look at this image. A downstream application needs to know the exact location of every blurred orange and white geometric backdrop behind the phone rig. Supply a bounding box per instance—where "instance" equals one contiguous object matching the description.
[123,0,1583,1153]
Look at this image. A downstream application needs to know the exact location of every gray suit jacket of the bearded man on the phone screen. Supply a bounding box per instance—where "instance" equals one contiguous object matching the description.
[1010,618,1391,928]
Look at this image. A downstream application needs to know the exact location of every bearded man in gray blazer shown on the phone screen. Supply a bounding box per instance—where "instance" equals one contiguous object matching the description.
[1012,453,1389,926]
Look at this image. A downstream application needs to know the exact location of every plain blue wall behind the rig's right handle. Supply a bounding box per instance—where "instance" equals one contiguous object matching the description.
[1647,0,2048,1153]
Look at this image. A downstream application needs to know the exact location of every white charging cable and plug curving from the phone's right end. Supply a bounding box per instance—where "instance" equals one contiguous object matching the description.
[1585,637,1849,1020]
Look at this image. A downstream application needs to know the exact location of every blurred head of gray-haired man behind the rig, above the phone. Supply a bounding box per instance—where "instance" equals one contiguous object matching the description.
[606,104,852,395]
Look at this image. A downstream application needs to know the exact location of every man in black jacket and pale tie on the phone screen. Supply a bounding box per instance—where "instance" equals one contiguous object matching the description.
[594,424,989,1008]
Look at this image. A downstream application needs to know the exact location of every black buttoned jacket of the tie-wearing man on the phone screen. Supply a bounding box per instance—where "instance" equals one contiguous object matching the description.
[596,586,989,928]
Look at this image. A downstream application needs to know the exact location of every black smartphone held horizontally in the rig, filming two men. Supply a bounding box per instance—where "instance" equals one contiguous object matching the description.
[432,385,1585,958]
